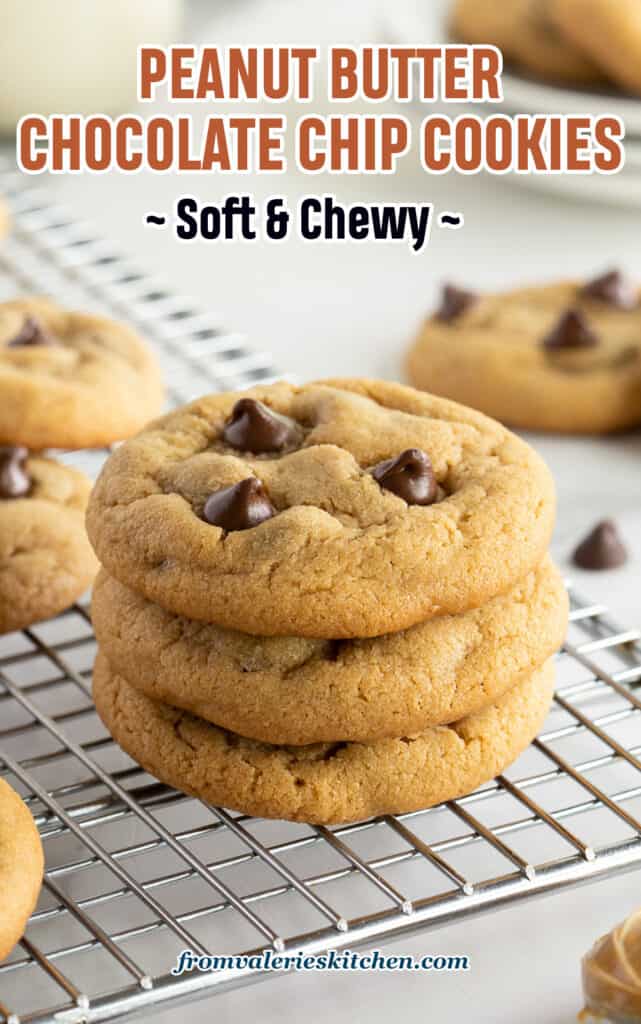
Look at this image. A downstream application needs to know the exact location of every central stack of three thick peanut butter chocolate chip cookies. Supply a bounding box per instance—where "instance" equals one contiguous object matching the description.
[87,380,567,823]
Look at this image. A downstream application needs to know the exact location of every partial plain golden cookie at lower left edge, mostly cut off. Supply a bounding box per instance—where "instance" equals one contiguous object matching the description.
[0,778,44,962]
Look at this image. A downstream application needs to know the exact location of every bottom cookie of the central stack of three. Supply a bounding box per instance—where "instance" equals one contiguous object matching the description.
[93,654,554,824]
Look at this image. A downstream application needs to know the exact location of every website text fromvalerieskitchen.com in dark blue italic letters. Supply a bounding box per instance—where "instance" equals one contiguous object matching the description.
[171,949,470,975]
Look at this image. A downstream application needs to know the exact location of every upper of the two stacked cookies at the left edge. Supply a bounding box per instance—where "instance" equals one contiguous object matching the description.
[0,298,163,450]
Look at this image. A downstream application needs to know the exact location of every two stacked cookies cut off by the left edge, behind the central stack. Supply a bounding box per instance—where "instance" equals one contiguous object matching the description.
[0,299,163,633]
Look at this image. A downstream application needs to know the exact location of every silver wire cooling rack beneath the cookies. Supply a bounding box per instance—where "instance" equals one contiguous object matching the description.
[0,157,641,1024]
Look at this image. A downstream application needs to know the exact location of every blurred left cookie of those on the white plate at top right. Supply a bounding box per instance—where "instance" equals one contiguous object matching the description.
[452,0,607,85]
